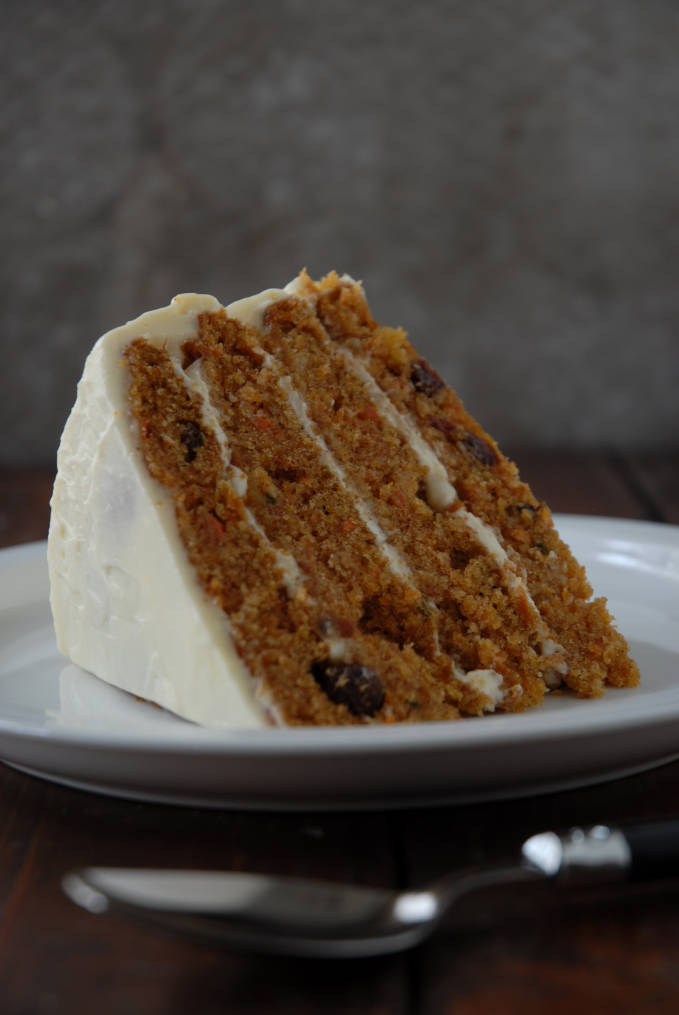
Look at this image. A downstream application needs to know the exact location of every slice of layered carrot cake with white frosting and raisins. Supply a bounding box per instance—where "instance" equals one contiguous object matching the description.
[48,272,638,727]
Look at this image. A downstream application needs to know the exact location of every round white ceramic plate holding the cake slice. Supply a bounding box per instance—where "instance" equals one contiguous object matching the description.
[0,516,679,809]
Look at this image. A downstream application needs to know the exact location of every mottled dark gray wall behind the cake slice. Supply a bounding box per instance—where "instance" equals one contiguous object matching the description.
[0,0,679,463]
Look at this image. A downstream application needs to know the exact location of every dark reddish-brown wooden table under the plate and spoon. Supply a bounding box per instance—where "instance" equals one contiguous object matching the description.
[0,453,679,1015]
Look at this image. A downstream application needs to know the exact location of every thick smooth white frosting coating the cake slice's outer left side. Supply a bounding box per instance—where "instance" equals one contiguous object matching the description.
[48,295,267,727]
